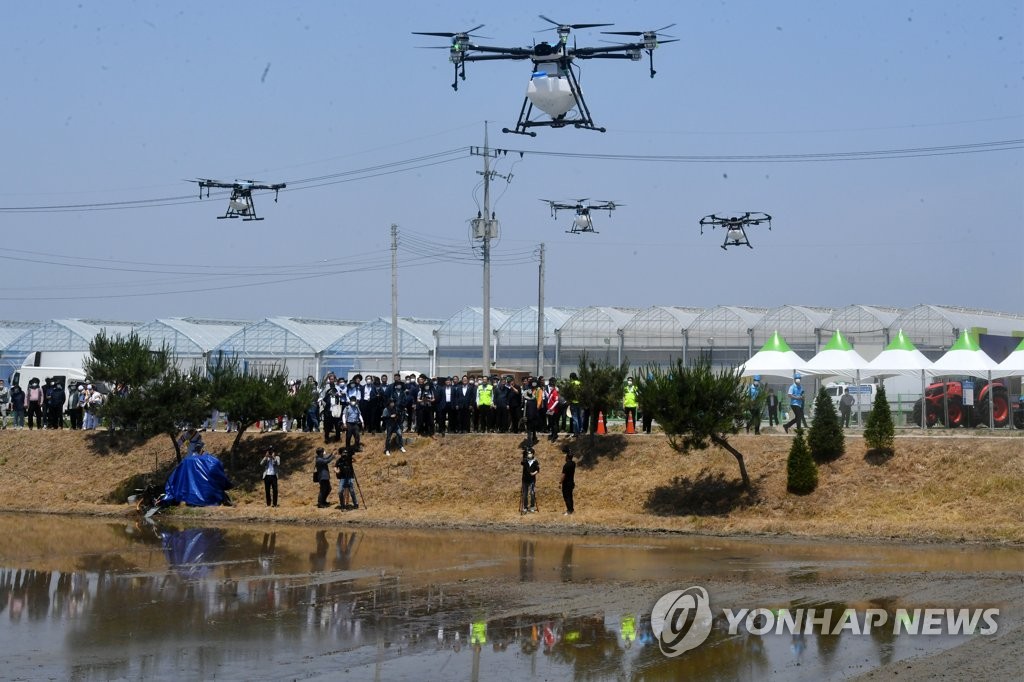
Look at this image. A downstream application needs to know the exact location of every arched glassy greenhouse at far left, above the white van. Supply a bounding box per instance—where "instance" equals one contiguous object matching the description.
[0,318,138,377]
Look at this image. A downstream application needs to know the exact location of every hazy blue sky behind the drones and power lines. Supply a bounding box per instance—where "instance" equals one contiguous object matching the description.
[0,0,1024,321]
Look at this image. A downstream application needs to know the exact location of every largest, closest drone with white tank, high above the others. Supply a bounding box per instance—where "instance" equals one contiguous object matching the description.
[413,14,678,137]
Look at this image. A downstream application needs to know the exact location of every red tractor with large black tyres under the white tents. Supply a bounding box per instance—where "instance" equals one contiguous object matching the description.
[908,379,1011,427]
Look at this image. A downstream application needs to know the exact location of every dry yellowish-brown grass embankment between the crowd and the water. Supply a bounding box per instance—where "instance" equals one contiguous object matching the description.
[0,430,1024,543]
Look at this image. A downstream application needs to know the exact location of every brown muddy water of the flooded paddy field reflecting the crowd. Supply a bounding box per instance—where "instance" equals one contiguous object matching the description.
[0,515,1024,680]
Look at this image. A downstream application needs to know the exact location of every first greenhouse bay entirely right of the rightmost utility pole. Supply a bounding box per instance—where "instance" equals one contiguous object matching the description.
[555,306,640,376]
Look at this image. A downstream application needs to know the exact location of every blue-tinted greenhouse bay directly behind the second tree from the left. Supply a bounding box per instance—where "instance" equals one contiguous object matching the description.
[210,317,362,379]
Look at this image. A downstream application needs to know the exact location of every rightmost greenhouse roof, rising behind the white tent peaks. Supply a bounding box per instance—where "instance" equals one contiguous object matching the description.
[891,304,1024,363]
